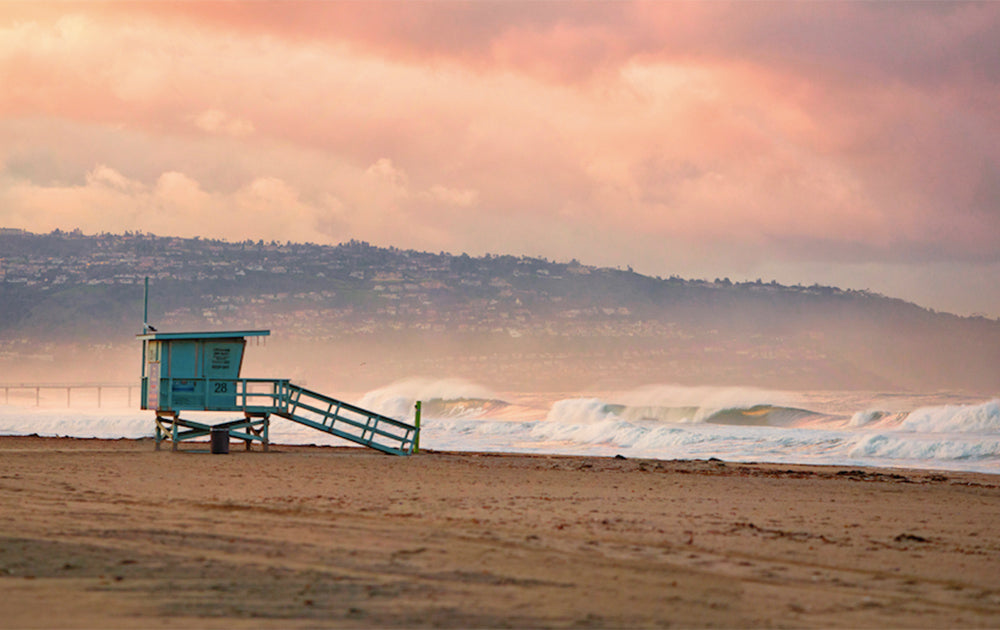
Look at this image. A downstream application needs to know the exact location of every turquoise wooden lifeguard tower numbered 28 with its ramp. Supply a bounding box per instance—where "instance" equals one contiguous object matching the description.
[138,325,419,455]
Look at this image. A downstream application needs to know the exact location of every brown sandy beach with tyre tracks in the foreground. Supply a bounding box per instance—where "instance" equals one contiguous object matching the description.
[0,437,1000,628]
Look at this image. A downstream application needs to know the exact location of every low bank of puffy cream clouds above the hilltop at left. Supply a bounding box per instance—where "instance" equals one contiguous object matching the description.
[0,159,476,253]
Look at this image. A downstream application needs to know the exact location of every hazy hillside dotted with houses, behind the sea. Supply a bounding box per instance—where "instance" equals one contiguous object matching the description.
[0,230,1000,393]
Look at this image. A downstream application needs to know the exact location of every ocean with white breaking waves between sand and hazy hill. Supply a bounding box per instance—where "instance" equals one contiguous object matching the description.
[0,379,1000,474]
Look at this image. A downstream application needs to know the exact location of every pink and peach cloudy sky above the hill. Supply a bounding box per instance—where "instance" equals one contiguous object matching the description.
[0,0,1000,317]
